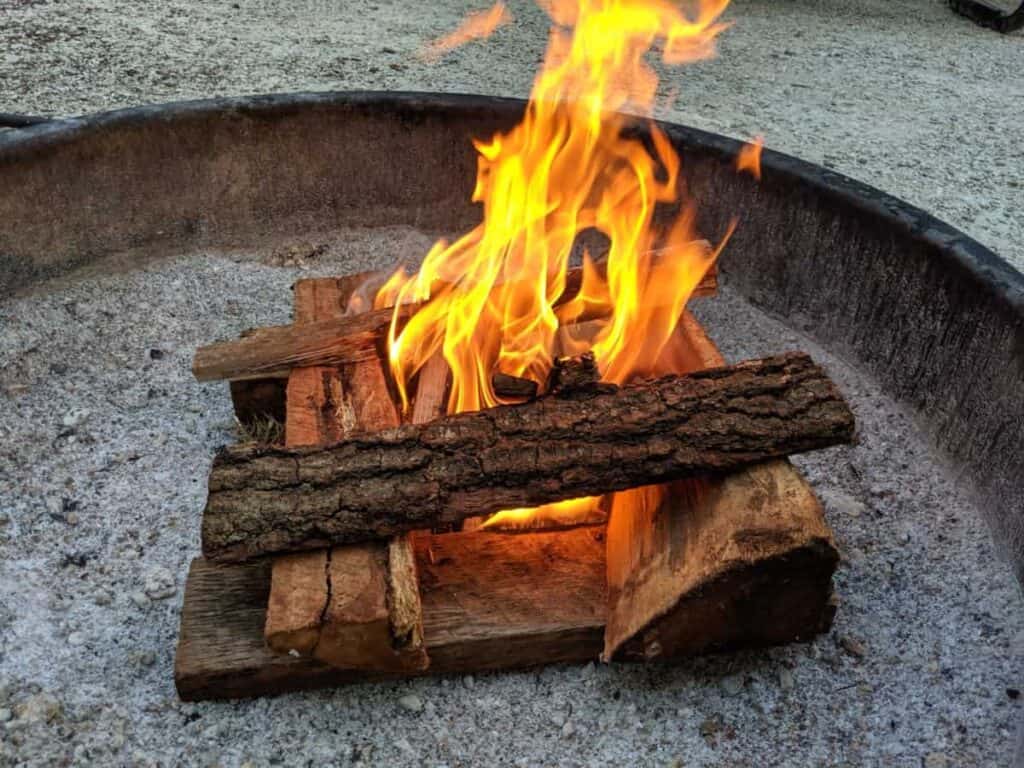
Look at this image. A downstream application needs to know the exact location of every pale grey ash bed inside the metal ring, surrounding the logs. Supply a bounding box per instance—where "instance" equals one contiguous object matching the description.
[0,236,1024,768]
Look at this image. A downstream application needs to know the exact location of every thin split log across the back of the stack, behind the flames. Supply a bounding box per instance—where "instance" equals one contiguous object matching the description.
[193,256,718,381]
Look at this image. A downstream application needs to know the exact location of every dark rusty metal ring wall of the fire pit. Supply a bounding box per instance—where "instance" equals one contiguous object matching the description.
[0,93,1024,768]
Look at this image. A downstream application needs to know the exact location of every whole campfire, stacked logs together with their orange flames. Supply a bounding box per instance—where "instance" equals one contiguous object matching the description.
[177,0,854,698]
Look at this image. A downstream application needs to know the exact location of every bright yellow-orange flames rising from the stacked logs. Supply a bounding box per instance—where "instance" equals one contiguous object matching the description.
[375,0,731,518]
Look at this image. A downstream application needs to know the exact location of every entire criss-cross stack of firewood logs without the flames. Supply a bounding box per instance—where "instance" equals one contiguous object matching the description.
[175,262,854,699]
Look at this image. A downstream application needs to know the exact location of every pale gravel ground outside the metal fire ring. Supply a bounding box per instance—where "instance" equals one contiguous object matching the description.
[0,0,1024,269]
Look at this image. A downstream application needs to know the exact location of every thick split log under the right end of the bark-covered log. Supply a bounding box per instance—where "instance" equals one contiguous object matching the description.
[602,312,839,660]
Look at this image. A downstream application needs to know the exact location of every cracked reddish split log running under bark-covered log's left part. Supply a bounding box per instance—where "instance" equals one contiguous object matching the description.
[264,278,429,670]
